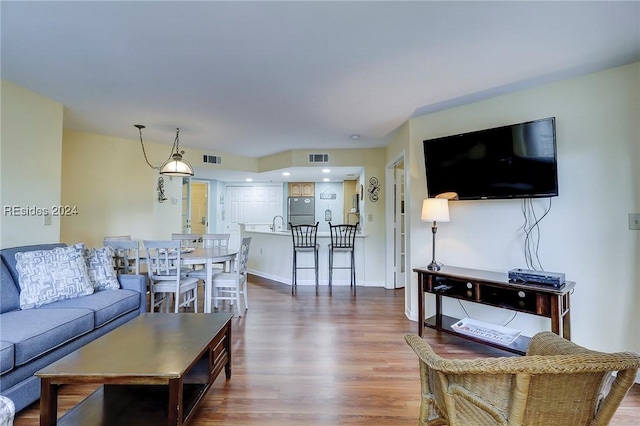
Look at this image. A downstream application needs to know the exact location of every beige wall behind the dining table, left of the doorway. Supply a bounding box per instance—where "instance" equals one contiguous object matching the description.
[60,131,182,247]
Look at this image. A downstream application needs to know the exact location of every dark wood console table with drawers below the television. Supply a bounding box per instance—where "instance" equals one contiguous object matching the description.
[413,266,575,355]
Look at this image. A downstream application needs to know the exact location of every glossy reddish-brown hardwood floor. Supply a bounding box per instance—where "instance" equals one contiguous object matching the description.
[14,277,640,426]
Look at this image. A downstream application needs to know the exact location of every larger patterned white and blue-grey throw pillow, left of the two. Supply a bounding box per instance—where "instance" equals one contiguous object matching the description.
[16,247,93,309]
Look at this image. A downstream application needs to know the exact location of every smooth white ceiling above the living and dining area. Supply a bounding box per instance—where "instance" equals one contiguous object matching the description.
[0,1,640,181]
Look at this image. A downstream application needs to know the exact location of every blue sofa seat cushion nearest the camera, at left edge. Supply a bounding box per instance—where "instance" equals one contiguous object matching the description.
[0,308,94,367]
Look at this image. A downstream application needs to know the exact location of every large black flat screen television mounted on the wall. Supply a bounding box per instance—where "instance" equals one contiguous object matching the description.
[423,117,558,200]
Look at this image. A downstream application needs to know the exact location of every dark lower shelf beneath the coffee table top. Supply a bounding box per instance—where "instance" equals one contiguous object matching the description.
[58,384,209,426]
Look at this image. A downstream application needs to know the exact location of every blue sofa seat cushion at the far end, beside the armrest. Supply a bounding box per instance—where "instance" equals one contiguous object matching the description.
[39,290,140,328]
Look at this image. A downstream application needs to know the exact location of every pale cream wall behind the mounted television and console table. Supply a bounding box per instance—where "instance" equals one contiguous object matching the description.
[400,63,640,352]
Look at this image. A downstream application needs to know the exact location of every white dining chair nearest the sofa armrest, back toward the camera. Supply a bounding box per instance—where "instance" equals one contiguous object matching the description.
[143,240,198,313]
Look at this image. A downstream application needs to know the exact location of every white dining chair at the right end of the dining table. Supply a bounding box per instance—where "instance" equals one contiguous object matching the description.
[211,237,251,316]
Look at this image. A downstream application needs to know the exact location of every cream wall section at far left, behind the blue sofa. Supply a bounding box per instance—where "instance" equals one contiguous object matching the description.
[0,81,63,247]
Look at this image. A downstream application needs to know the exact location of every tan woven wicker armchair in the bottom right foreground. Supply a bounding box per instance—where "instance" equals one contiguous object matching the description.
[405,331,640,426]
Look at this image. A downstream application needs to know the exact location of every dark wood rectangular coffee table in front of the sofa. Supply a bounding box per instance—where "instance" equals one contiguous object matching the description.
[36,313,233,426]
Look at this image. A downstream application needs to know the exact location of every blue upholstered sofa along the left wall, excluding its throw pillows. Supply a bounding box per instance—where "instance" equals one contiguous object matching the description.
[0,244,146,411]
